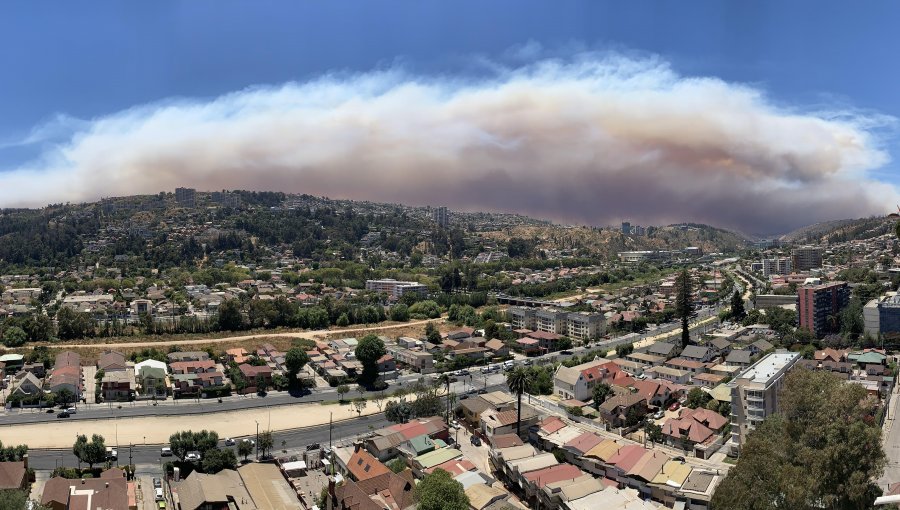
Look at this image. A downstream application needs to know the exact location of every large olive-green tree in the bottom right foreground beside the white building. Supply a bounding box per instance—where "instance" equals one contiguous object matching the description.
[711,369,886,510]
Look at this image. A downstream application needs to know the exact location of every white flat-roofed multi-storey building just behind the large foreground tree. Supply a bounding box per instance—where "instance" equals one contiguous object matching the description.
[728,352,801,453]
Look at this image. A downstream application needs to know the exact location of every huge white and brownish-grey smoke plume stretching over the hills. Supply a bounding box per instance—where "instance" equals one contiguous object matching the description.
[0,55,900,233]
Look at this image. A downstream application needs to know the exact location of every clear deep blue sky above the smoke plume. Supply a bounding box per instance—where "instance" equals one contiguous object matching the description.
[0,0,900,233]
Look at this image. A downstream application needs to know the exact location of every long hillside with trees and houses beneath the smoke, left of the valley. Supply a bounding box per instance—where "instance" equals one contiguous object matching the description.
[0,191,746,273]
